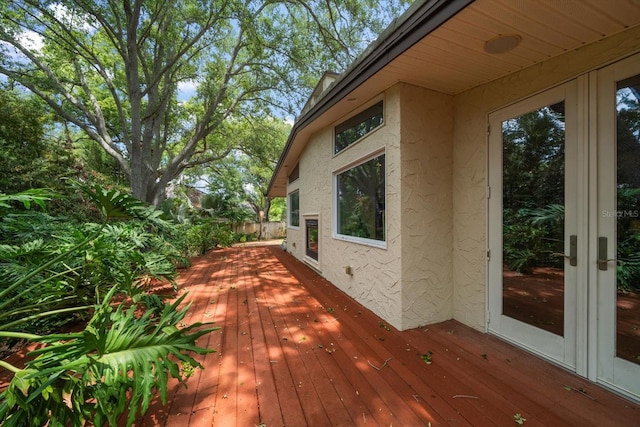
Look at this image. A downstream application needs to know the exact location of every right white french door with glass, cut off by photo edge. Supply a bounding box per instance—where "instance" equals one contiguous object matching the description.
[589,56,640,399]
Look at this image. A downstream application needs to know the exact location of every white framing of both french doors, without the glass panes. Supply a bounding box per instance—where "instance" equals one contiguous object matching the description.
[486,53,640,401]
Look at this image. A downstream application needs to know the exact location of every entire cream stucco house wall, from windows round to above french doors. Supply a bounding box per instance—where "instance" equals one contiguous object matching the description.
[287,24,640,330]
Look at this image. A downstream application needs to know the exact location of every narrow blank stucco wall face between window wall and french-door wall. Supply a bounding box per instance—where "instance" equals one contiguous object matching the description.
[400,84,453,329]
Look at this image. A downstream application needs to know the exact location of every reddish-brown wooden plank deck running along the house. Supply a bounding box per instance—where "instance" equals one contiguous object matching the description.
[124,246,640,427]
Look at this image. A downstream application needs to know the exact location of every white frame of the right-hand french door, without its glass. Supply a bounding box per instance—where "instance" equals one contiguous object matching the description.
[588,54,640,400]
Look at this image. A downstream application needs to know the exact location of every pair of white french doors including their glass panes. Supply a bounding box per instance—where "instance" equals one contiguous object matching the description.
[488,52,640,400]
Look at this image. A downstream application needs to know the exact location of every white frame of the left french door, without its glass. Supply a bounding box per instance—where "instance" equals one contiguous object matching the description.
[487,79,587,371]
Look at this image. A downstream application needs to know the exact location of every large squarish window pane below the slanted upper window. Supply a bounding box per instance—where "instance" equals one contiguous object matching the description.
[336,154,385,241]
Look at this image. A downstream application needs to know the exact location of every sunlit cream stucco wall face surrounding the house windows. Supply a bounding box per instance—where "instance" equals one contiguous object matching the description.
[287,88,402,327]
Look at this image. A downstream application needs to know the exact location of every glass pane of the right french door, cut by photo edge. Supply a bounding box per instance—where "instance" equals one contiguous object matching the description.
[616,76,640,364]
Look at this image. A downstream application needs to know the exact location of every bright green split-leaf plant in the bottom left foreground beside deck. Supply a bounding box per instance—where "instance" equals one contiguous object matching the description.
[0,288,214,426]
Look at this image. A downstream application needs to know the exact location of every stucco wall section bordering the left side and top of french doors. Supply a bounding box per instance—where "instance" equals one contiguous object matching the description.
[453,24,640,330]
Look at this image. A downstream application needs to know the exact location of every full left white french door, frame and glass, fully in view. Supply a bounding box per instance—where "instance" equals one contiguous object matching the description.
[489,82,584,370]
